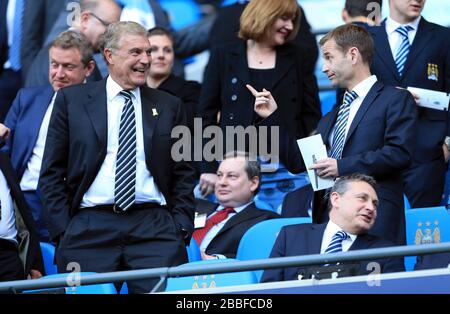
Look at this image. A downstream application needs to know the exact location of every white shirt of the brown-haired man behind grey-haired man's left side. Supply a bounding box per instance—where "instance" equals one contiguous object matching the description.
[20,93,56,191]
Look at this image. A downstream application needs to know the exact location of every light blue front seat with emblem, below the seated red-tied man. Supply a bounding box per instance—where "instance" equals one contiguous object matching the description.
[166,259,258,291]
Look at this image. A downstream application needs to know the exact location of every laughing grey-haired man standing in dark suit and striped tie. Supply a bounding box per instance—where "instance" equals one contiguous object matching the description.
[39,22,194,293]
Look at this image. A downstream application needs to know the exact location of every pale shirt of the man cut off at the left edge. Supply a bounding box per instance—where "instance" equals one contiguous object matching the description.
[0,171,17,244]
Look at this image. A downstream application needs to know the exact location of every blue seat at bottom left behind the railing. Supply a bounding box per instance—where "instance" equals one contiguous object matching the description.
[24,272,117,294]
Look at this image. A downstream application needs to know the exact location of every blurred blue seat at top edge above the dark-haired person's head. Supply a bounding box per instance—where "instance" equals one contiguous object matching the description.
[159,0,201,30]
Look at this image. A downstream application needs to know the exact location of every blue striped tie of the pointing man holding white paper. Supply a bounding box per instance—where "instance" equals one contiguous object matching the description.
[330,91,358,159]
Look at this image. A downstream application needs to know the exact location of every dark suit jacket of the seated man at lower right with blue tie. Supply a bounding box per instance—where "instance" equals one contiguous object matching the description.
[261,224,405,282]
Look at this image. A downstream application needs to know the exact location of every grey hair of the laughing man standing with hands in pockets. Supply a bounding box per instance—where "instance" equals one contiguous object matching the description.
[100,21,147,60]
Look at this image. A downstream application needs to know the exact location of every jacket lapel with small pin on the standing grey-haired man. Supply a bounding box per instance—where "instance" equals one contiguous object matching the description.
[140,87,164,159]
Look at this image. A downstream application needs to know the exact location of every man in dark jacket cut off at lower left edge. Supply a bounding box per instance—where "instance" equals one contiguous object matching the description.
[0,131,45,281]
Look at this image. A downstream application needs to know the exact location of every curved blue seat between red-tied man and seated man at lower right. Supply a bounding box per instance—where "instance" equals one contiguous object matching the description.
[236,217,311,282]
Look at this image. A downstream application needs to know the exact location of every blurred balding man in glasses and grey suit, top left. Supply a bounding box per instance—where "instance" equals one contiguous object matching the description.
[25,0,121,87]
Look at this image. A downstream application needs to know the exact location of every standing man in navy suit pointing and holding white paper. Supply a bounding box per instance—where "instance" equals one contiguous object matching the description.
[264,24,417,244]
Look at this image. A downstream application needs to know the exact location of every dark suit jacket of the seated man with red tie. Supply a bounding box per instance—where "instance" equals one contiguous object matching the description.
[196,200,280,258]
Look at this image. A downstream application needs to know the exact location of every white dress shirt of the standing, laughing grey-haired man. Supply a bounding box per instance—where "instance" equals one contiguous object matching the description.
[80,76,167,207]
